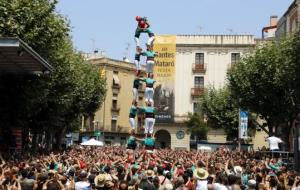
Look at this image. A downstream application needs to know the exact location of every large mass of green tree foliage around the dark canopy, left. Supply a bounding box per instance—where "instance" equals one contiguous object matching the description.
[0,0,106,149]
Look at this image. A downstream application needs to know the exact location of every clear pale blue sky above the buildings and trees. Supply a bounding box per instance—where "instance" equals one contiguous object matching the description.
[57,0,292,60]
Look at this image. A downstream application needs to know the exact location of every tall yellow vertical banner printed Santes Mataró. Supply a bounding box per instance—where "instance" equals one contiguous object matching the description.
[154,35,176,123]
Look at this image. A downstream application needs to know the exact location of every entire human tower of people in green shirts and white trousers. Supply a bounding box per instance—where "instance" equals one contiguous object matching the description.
[127,16,156,152]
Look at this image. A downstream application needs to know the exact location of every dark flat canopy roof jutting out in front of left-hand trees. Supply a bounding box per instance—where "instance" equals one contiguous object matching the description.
[0,37,53,74]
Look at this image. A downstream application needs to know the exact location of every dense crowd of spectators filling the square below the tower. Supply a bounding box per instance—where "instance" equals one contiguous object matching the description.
[0,146,300,190]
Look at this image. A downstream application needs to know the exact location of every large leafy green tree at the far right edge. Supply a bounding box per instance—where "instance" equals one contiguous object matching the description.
[227,27,300,147]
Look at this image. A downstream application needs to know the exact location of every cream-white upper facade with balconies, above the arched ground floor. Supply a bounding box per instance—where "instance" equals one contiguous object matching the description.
[175,35,256,117]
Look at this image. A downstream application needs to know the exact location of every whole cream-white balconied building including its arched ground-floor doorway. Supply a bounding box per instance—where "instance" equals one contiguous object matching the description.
[155,35,256,149]
